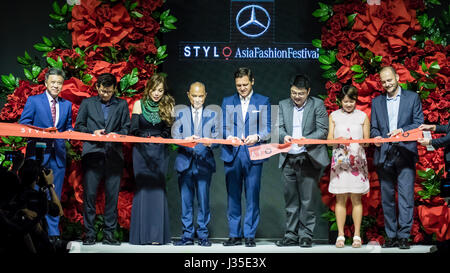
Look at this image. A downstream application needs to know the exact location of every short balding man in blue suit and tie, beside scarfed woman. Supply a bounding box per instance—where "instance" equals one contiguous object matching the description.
[172,82,219,246]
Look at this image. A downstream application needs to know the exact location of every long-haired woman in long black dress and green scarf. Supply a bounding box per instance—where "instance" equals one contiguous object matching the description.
[130,74,175,245]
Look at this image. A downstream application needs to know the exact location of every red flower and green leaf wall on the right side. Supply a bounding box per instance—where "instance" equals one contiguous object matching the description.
[313,0,450,243]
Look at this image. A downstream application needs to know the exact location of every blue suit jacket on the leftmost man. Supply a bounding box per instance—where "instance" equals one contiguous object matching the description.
[19,91,73,167]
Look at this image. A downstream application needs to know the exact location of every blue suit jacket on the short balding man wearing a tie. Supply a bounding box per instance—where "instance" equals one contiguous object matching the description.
[172,107,220,173]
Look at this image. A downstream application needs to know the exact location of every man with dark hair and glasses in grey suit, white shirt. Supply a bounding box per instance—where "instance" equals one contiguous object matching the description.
[275,75,330,247]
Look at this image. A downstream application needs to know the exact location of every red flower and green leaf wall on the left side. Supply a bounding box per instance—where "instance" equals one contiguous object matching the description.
[0,0,177,239]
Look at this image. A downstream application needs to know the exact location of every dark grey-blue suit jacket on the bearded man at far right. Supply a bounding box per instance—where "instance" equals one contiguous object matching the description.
[370,89,423,165]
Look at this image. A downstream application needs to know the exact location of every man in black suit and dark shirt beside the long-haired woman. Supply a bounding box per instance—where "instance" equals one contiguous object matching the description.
[75,73,130,245]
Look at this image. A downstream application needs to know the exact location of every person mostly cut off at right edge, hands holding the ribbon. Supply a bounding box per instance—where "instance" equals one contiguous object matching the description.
[417,123,450,196]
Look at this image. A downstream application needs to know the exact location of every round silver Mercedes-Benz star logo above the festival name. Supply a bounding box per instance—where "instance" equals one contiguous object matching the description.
[236,5,270,38]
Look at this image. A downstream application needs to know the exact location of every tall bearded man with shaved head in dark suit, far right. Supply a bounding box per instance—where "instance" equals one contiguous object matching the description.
[370,66,423,249]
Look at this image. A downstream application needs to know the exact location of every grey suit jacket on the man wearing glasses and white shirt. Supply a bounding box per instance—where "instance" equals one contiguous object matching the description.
[278,97,330,169]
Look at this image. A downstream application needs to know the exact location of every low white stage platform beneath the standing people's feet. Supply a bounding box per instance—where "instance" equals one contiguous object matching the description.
[68,240,433,254]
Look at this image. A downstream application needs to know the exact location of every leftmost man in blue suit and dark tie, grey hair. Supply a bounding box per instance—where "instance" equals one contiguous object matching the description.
[19,68,73,242]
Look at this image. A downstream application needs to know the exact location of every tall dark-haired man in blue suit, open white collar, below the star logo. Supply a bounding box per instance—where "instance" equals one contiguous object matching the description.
[221,67,271,247]
